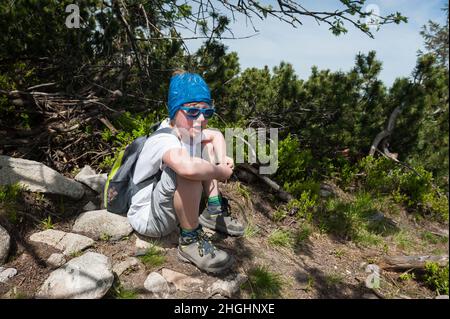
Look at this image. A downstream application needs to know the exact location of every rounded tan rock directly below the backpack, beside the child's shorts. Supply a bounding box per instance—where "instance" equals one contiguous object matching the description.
[72,209,133,240]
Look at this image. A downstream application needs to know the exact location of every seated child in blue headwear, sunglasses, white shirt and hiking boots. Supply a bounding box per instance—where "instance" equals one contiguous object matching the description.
[127,72,244,273]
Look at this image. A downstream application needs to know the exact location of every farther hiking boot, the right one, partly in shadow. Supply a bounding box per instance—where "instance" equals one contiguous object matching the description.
[199,197,245,236]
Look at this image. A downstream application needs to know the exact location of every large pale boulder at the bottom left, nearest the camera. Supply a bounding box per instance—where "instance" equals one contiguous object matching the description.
[36,252,114,299]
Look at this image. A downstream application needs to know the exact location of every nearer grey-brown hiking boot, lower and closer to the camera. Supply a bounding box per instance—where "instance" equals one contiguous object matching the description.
[178,226,234,274]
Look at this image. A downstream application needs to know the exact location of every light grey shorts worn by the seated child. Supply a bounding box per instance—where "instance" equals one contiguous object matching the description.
[128,167,178,237]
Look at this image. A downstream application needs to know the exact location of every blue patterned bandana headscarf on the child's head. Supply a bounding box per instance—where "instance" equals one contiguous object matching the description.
[168,73,212,119]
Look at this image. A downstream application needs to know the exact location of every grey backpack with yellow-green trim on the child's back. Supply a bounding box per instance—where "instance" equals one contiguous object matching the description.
[103,124,172,215]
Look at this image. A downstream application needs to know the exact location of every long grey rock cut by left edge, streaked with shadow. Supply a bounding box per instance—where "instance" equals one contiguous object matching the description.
[0,155,84,199]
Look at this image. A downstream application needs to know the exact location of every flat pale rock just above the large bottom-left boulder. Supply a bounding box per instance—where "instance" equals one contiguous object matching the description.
[30,229,94,256]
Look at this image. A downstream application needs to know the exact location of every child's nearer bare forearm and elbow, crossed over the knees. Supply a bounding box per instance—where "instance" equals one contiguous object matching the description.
[162,148,233,181]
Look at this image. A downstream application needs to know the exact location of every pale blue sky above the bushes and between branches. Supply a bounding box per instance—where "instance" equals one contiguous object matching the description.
[179,0,447,86]
